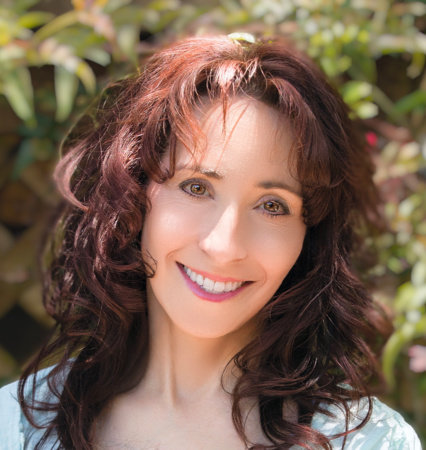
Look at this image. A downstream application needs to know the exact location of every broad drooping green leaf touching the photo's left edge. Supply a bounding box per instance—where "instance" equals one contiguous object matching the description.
[2,67,34,123]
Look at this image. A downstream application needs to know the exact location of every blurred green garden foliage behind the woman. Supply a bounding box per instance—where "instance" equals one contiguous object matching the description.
[0,0,426,444]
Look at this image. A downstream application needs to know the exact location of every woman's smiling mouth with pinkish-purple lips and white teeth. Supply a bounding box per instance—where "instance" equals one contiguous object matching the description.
[178,263,250,302]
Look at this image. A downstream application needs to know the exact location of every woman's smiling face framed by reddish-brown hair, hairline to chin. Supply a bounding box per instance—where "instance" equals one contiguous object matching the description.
[142,97,305,338]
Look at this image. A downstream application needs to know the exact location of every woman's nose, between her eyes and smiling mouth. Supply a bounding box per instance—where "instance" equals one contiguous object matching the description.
[199,206,247,264]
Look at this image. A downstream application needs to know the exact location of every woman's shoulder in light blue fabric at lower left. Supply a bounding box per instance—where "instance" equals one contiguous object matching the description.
[0,368,62,450]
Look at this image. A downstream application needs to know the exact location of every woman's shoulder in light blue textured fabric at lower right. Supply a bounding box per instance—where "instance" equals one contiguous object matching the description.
[312,398,421,450]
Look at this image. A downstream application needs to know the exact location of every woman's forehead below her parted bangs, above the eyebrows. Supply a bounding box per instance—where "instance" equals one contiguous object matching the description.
[165,97,301,192]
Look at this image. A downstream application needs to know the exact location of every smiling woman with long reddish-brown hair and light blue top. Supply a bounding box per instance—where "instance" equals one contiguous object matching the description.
[1,37,420,449]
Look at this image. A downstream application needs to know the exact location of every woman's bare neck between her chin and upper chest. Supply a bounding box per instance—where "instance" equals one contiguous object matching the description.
[140,294,255,406]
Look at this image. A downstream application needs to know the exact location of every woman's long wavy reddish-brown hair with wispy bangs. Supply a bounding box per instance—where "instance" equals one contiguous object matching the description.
[19,37,386,450]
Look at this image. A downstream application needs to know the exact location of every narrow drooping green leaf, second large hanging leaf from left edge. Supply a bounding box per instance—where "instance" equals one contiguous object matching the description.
[55,66,78,122]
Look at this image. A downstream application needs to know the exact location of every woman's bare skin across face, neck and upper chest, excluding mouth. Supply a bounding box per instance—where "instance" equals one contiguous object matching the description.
[96,97,306,450]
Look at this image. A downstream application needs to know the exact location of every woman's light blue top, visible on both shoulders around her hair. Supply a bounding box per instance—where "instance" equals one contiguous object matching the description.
[0,371,421,450]
